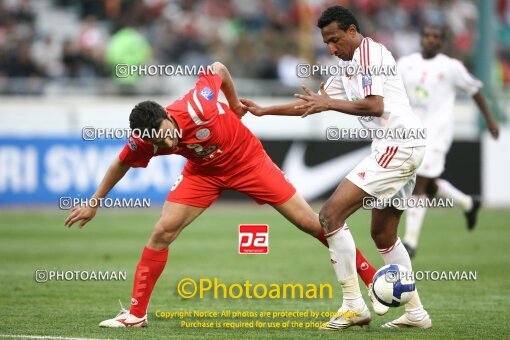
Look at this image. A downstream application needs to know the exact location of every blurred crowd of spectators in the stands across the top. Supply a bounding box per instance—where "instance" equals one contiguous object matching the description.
[0,0,510,94]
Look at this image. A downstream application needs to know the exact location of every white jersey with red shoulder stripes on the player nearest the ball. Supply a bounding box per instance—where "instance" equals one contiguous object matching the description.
[325,38,425,147]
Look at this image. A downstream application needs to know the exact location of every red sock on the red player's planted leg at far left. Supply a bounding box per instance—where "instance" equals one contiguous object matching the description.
[129,247,168,318]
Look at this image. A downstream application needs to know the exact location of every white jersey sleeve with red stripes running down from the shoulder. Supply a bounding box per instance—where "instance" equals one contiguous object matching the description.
[354,38,382,98]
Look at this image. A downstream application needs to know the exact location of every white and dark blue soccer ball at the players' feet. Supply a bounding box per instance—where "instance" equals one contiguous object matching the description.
[372,264,416,307]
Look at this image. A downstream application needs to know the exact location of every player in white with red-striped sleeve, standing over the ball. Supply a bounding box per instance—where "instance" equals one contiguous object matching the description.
[241,6,432,330]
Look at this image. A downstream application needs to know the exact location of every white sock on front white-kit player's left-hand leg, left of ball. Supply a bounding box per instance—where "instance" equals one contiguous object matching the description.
[325,224,364,310]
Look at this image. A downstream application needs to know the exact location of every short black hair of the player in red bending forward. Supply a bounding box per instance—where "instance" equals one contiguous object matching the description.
[129,100,168,136]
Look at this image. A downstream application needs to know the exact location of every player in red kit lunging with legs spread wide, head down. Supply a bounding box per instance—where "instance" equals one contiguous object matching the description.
[65,62,383,328]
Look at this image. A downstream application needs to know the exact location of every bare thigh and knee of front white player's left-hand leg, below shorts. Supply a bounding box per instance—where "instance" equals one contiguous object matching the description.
[319,178,370,232]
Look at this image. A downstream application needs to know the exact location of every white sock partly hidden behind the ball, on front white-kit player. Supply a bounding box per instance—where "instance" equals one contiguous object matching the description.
[378,238,427,320]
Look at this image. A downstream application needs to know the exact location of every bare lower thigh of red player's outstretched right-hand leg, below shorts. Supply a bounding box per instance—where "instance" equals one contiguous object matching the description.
[273,192,321,235]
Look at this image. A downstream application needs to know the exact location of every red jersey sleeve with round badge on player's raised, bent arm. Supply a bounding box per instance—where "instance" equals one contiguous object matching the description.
[188,73,221,120]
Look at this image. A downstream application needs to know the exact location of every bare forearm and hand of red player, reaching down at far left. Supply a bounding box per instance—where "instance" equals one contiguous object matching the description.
[64,158,130,228]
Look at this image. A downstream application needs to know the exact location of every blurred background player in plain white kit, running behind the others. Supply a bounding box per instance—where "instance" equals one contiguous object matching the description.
[398,25,499,257]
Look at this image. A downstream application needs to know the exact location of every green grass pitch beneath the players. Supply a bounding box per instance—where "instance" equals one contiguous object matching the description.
[0,204,510,339]
